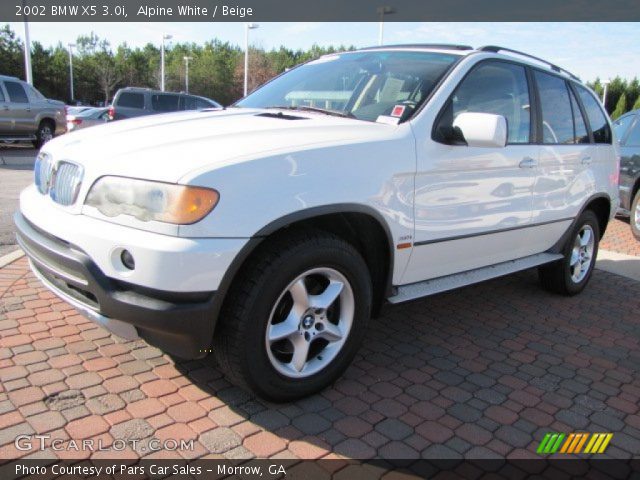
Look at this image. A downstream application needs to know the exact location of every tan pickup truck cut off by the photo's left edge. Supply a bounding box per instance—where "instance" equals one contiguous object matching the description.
[0,75,67,148]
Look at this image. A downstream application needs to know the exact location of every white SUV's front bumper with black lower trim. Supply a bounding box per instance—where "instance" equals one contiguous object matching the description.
[14,213,216,358]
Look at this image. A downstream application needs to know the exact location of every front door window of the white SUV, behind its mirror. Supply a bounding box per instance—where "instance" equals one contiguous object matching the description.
[436,62,531,143]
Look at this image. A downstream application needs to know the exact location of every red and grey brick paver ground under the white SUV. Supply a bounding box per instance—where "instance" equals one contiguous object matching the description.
[0,226,640,459]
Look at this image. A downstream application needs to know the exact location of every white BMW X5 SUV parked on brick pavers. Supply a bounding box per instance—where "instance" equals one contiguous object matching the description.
[15,45,619,400]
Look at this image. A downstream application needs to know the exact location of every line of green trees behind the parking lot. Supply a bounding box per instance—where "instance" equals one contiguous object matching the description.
[0,25,640,119]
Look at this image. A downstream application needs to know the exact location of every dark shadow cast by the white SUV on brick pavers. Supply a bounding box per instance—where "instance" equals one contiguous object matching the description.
[169,271,640,459]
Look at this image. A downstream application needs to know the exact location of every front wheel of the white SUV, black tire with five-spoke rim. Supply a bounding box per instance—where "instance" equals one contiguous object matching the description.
[213,231,372,402]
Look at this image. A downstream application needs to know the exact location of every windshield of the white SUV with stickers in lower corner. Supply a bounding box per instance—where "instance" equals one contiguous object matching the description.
[235,51,460,122]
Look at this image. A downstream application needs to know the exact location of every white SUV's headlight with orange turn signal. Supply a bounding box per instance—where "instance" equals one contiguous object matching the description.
[85,177,220,225]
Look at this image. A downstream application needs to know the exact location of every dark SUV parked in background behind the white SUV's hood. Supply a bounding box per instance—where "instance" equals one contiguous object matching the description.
[109,87,222,120]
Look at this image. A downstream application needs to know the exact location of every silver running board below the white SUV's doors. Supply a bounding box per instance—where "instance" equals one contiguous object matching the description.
[387,253,563,303]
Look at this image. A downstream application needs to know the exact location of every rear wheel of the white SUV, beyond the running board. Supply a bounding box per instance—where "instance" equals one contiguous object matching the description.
[538,210,600,296]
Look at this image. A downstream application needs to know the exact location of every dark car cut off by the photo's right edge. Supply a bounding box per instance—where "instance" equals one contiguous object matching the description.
[613,110,640,240]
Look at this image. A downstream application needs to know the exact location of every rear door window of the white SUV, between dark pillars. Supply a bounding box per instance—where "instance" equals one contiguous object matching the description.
[534,70,576,145]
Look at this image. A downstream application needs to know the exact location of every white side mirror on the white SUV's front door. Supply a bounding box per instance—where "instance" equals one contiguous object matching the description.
[453,112,507,148]
